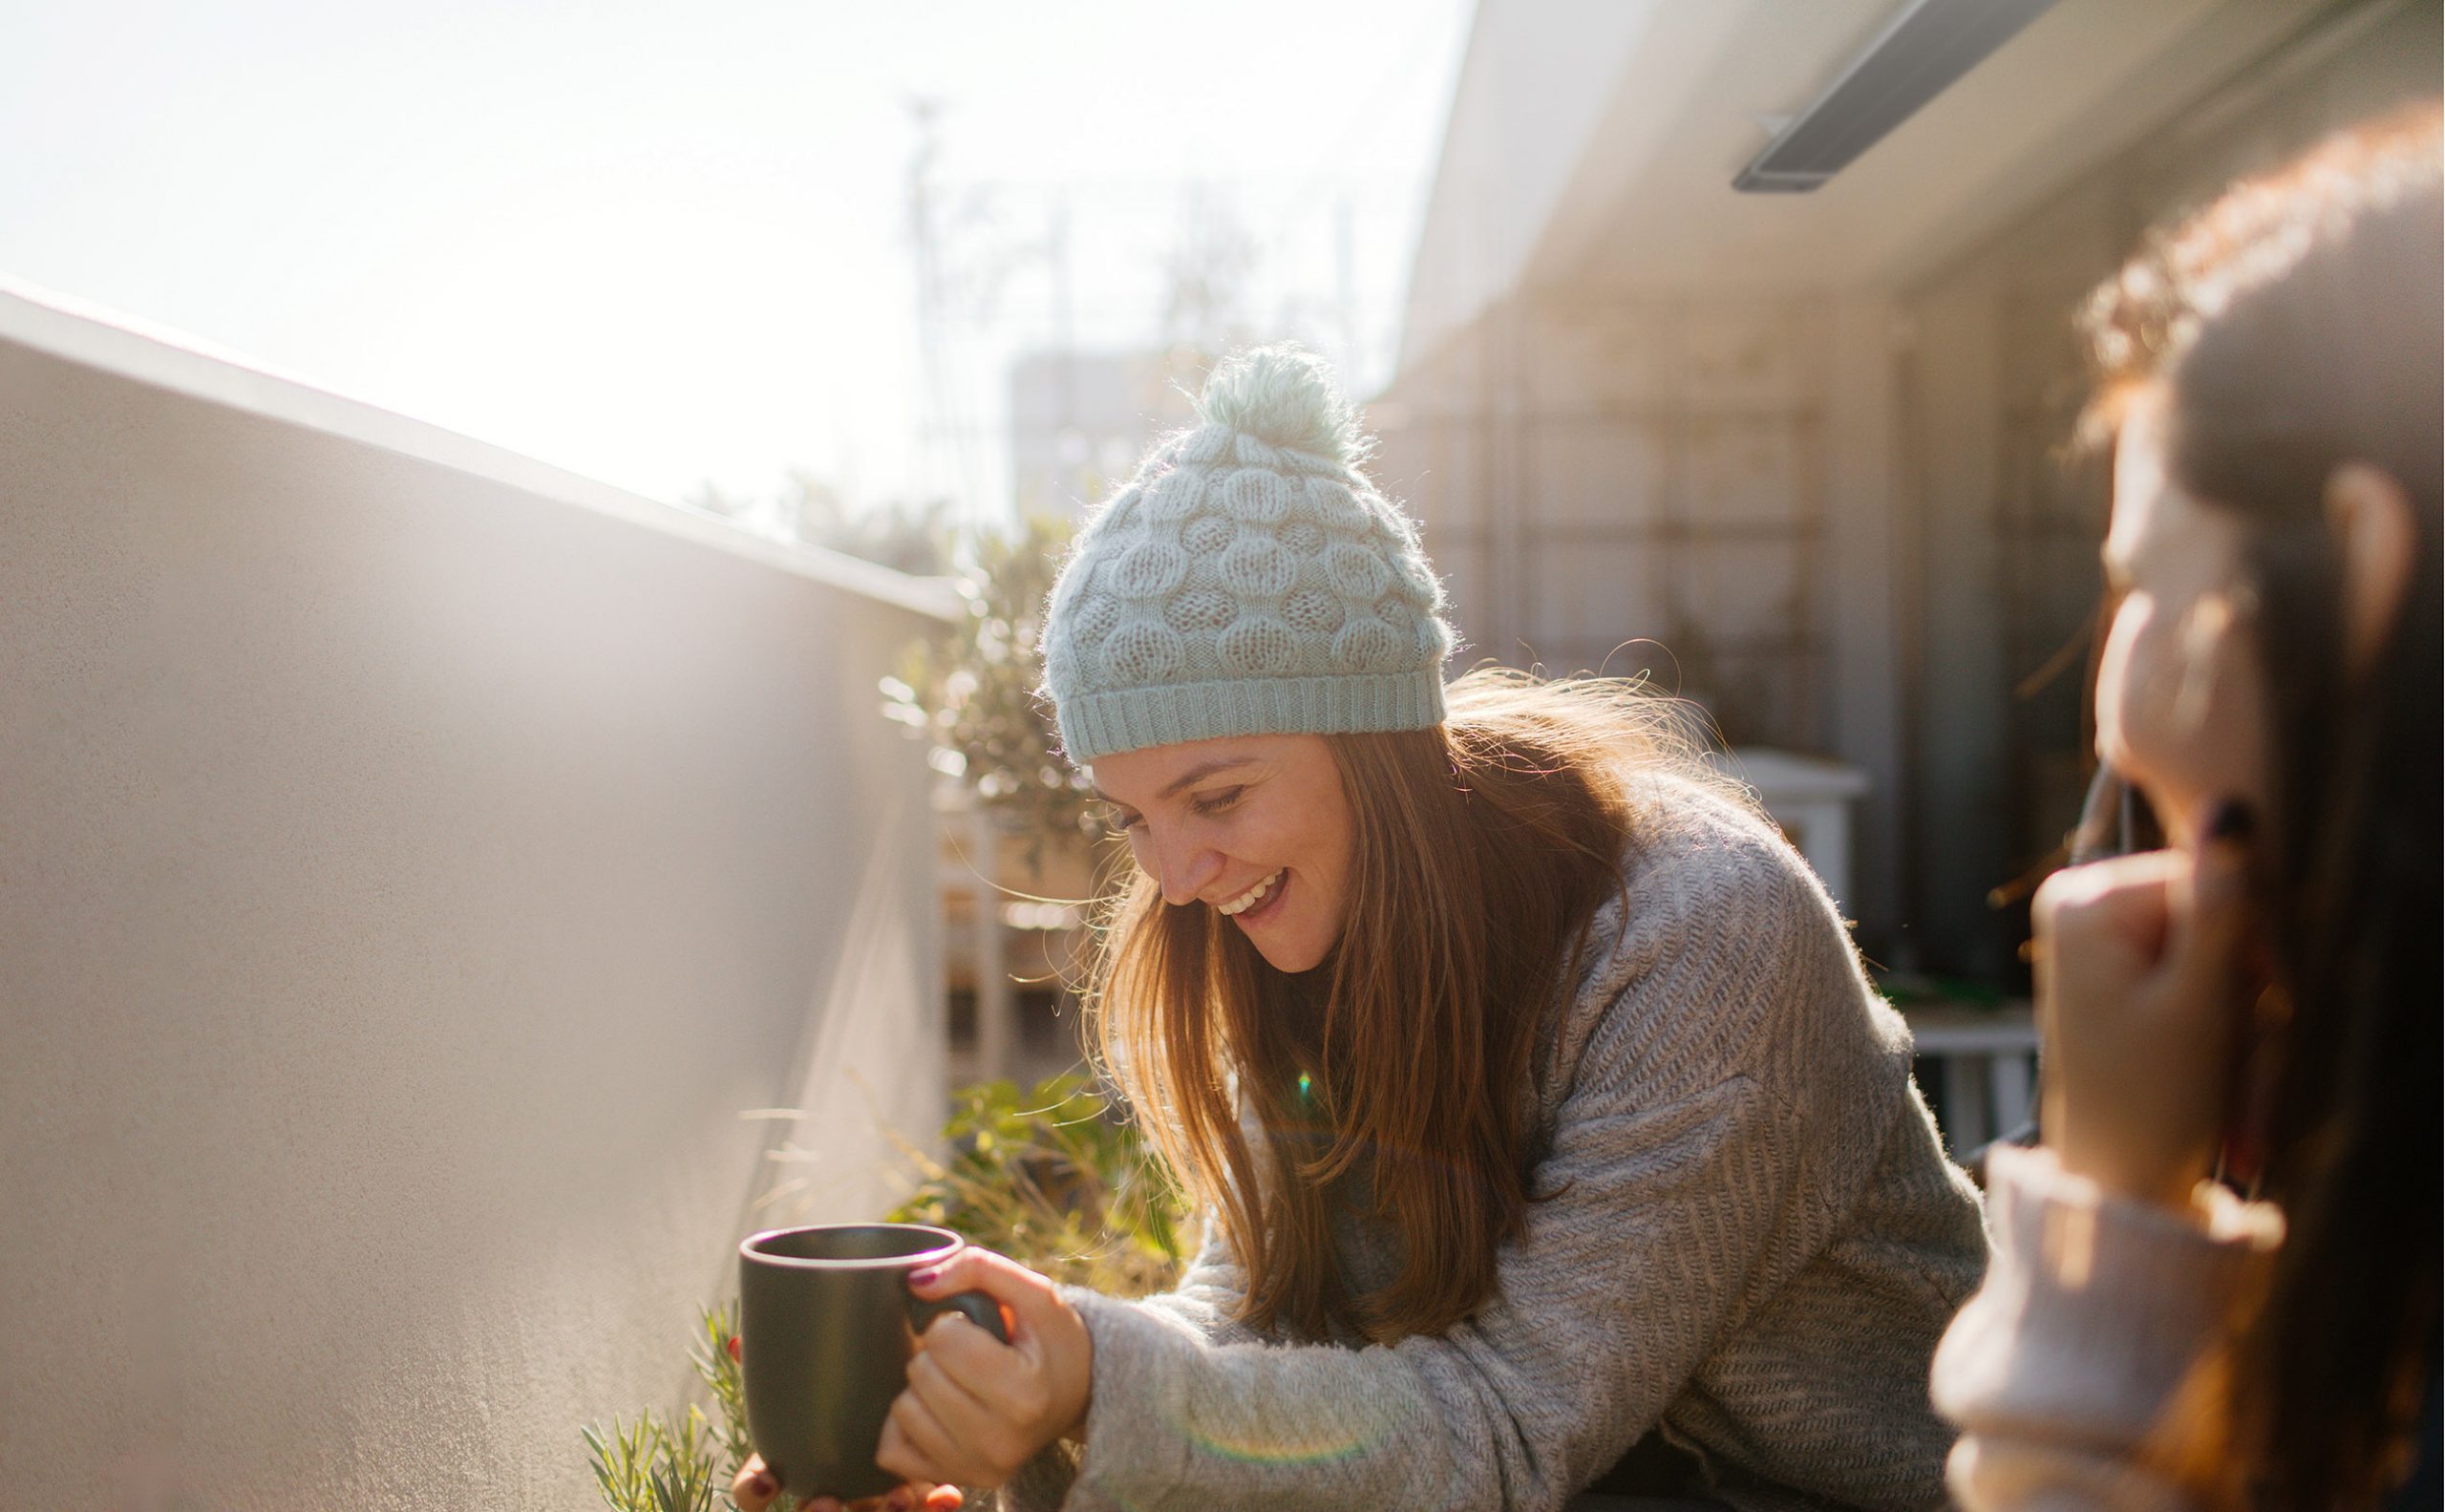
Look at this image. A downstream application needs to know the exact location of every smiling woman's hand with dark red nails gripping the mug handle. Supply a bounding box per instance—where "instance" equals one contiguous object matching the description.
[875,1247,1095,1485]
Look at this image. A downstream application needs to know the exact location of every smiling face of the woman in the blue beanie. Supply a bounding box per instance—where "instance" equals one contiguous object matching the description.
[1093,734,1352,971]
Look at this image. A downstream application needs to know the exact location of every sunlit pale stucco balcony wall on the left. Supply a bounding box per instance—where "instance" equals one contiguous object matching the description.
[0,293,942,1512]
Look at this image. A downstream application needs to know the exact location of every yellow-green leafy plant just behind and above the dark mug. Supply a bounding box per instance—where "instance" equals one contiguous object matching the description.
[892,1072,1188,1297]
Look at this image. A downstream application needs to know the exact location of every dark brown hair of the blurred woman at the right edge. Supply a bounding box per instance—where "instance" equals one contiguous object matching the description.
[2088,105,2445,1507]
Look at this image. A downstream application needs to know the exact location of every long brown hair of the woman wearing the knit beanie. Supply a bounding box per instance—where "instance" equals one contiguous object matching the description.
[1088,671,1712,1343]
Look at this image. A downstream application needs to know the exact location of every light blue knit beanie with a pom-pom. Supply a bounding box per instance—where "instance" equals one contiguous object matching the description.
[1044,348,1453,766]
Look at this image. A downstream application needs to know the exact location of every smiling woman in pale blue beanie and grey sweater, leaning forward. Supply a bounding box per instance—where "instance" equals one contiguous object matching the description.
[741,350,1986,1512]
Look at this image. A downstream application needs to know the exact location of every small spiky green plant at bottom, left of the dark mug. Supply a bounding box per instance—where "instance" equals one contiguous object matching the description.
[577,1302,751,1512]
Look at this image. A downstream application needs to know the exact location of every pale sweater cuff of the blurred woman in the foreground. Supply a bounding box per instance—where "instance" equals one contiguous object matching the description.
[1934,1150,2281,1512]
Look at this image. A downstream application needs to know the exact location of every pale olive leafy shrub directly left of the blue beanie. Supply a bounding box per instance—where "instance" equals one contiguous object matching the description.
[882,516,1103,859]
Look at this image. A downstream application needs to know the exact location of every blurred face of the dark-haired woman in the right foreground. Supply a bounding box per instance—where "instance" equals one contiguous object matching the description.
[2097,396,2269,844]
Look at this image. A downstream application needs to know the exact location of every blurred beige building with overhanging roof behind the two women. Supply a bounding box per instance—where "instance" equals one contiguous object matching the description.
[1371,0,2440,986]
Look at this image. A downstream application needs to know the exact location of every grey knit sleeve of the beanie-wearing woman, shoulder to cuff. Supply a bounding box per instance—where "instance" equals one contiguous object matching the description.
[1022,817,1900,1512]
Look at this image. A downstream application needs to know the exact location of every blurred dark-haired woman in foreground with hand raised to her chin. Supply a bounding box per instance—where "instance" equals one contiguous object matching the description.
[1934,105,2445,1509]
